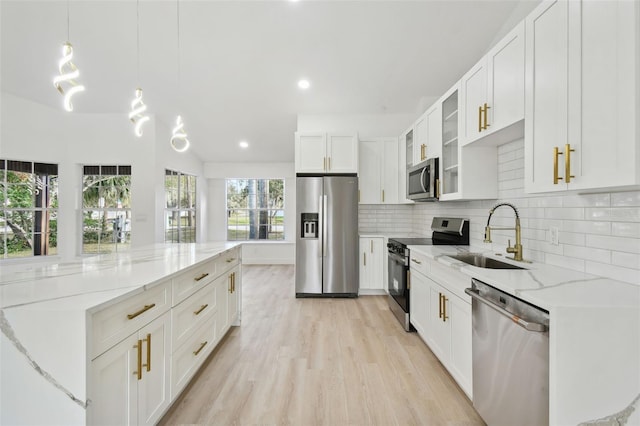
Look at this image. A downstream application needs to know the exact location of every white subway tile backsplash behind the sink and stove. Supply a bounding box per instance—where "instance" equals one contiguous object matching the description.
[359,139,640,284]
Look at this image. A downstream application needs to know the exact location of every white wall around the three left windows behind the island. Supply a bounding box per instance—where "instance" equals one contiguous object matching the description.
[0,92,207,258]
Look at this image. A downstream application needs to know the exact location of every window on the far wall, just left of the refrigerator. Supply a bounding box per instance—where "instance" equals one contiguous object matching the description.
[227,179,284,241]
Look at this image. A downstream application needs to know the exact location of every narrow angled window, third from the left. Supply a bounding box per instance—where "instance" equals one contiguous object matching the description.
[164,170,196,243]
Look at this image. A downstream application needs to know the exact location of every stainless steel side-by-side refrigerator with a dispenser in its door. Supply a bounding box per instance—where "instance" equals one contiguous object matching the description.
[296,176,359,297]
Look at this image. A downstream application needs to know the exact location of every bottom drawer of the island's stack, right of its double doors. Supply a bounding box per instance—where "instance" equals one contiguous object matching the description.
[171,315,216,400]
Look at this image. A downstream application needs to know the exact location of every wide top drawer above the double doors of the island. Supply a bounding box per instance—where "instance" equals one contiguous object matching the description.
[91,281,170,359]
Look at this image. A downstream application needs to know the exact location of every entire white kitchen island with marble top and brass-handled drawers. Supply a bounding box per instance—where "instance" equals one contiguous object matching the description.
[0,242,241,424]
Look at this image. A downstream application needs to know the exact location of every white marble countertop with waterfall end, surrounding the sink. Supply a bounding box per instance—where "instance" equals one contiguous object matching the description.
[409,246,640,425]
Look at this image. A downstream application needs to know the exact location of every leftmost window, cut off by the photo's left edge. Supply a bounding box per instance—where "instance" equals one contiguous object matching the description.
[0,159,58,259]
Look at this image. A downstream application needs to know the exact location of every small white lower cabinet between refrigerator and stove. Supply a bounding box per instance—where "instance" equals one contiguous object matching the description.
[359,237,387,294]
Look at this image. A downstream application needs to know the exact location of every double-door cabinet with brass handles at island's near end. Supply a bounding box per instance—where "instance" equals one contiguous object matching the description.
[90,312,171,425]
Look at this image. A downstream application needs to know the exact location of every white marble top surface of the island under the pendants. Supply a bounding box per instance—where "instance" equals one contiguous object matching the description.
[0,241,239,311]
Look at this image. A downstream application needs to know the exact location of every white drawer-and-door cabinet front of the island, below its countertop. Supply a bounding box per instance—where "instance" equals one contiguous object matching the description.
[87,248,241,425]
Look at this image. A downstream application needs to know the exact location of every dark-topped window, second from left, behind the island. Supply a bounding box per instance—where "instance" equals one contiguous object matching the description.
[82,166,131,254]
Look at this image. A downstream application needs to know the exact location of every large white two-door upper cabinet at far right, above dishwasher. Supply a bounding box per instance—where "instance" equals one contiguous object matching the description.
[525,0,640,192]
